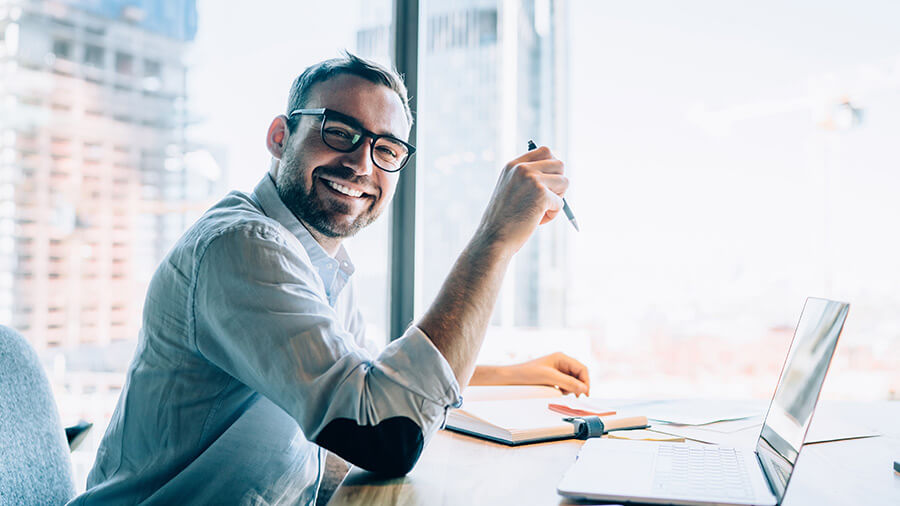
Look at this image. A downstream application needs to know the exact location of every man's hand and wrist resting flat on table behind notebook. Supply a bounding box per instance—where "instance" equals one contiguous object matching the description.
[469,352,591,395]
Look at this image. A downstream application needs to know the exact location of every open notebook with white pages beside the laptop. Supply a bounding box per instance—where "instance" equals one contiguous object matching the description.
[447,387,647,445]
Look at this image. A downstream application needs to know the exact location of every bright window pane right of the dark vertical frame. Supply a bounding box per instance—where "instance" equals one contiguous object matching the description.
[416,0,900,399]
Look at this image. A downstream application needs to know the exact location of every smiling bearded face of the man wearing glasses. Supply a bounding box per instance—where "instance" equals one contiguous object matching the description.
[275,74,409,238]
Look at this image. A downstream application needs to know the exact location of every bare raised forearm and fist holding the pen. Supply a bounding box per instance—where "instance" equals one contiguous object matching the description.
[418,147,569,385]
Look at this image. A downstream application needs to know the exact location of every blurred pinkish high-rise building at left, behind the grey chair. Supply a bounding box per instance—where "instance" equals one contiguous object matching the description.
[0,0,218,350]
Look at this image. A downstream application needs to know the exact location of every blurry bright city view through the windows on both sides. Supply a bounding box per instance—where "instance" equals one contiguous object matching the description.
[0,0,900,488]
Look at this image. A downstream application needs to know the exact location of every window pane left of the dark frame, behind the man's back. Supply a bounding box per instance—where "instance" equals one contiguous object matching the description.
[0,0,392,488]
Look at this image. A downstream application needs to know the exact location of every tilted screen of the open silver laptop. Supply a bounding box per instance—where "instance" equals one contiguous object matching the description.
[756,297,850,503]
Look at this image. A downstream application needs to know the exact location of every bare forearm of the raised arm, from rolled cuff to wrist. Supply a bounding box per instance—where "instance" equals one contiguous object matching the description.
[418,237,511,385]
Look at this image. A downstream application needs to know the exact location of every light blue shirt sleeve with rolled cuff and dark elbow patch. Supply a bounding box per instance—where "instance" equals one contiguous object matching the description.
[191,224,461,475]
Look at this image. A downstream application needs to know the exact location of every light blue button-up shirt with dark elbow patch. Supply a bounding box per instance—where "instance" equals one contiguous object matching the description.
[71,175,461,505]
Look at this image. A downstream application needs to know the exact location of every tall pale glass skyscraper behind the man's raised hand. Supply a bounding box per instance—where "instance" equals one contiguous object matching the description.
[357,0,572,327]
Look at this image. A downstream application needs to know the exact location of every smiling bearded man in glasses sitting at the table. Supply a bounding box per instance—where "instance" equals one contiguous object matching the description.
[73,55,588,504]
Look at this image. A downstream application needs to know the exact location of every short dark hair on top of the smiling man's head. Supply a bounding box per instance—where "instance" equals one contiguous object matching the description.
[285,51,413,130]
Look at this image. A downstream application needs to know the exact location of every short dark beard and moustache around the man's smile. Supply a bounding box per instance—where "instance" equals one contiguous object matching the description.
[275,150,382,238]
